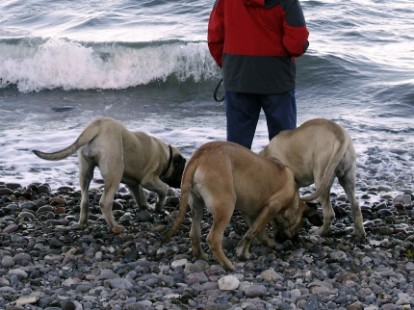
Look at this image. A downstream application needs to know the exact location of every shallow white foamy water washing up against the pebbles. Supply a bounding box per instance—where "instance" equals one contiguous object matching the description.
[0,103,414,202]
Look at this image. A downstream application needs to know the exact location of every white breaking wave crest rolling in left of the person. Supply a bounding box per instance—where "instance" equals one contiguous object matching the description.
[0,39,220,92]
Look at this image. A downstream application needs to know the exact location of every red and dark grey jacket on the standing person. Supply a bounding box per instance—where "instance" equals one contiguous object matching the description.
[208,0,309,94]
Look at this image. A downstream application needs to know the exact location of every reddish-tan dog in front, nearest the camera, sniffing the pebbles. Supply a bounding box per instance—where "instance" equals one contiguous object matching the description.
[164,142,314,270]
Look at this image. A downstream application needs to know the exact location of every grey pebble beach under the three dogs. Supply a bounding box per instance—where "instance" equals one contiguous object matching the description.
[0,182,414,310]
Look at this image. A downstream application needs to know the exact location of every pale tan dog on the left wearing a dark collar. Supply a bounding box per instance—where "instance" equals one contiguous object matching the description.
[33,118,186,233]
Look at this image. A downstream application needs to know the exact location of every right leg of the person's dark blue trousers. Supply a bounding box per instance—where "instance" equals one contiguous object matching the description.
[261,90,296,140]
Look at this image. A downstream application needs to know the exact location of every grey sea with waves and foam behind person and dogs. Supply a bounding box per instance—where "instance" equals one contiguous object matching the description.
[0,0,414,199]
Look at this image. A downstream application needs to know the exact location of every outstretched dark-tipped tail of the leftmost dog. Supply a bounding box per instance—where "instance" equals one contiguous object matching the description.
[32,121,99,161]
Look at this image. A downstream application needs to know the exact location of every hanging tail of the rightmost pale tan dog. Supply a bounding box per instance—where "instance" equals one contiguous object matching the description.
[301,129,350,201]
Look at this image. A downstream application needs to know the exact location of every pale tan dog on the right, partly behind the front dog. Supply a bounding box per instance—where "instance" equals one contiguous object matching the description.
[261,119,365,238]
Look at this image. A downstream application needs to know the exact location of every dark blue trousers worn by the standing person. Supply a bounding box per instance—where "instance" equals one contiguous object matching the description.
[225,90,296,149]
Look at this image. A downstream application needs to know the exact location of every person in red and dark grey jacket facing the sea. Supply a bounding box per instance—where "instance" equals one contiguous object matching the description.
[207,0,309,149]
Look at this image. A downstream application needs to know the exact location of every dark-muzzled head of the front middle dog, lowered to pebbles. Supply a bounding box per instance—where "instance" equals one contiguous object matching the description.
[275,200,323,239]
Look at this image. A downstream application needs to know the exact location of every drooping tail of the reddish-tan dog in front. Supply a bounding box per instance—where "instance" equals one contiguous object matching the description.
[163,161,196,243]
